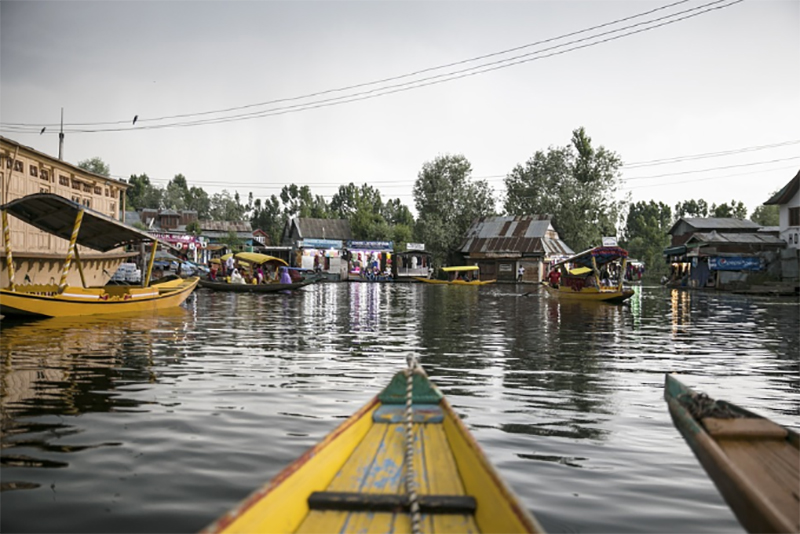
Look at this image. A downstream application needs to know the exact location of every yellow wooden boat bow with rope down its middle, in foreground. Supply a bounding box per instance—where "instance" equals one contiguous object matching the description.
[204,368,542,533]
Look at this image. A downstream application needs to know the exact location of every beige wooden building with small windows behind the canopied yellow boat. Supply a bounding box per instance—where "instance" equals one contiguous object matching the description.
[0,136,131,287]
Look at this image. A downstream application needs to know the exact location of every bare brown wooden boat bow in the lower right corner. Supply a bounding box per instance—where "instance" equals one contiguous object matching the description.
[664,375,800,532]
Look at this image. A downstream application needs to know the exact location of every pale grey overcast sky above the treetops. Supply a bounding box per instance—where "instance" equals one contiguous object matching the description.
[0,0,800,220]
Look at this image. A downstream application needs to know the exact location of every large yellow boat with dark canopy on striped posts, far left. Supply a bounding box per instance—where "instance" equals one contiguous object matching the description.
[0,193,199,317]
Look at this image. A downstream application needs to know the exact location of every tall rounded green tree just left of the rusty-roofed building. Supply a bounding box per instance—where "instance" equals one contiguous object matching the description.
[414,155,495,265]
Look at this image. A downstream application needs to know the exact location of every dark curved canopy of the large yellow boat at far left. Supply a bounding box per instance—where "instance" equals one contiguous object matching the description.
[0,193,164,252]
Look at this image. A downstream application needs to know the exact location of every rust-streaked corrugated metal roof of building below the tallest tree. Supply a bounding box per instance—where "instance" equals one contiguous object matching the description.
[461,215,572,256]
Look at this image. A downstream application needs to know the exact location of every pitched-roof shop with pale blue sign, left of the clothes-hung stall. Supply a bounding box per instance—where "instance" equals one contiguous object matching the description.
[281,217,353,282]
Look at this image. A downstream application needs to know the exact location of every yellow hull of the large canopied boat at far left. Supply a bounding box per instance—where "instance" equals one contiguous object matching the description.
[0,277,199,317]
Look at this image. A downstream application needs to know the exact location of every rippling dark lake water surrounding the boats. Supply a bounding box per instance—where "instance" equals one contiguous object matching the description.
[0,283,800,533]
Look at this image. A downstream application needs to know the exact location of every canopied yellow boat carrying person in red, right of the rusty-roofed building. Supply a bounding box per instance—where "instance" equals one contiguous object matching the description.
[544,247,634,302]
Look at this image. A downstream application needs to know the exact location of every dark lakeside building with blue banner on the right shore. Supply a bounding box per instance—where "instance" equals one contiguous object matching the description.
[664,217,786,289]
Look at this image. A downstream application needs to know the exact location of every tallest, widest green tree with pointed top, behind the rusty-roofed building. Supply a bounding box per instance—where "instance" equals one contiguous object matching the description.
[505,128,624,252]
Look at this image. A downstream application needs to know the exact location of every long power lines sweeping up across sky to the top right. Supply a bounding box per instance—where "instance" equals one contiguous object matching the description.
[0,0,743,133]
